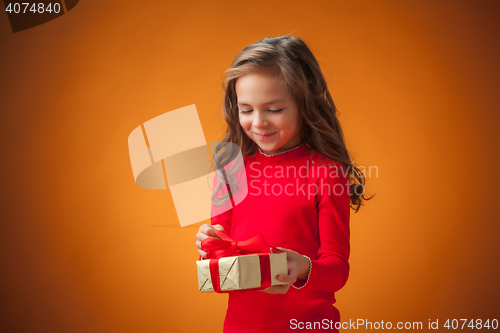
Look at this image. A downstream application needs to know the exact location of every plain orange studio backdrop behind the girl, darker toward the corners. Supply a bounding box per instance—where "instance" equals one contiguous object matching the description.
[0,0,500,332]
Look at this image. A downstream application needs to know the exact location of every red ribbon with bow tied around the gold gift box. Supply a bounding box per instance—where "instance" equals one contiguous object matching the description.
[201,228,283,293]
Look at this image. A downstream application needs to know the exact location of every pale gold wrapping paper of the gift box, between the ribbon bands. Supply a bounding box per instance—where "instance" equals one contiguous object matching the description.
[196,253,288,292]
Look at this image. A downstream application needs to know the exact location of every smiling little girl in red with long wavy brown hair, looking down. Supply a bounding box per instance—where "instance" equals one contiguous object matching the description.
[196,36,370,333]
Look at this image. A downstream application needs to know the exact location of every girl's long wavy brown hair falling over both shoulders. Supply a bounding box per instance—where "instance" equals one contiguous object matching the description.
[212,36,373,212]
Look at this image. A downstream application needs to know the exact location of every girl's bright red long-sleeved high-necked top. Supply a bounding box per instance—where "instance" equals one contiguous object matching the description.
[211,143,350,333]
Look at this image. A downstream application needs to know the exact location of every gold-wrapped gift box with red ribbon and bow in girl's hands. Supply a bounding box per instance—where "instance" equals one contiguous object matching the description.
[196,229,288,293]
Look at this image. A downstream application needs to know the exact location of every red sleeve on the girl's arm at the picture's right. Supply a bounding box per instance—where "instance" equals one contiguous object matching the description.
[294,164,350,292]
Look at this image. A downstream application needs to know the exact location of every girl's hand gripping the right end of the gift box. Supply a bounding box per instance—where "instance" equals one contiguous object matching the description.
[261,247,309,294]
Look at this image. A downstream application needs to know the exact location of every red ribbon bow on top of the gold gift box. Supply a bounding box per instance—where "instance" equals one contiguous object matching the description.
[201,228,281,259]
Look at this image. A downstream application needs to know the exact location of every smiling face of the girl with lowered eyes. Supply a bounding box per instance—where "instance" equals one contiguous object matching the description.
[235,73,302,154]
